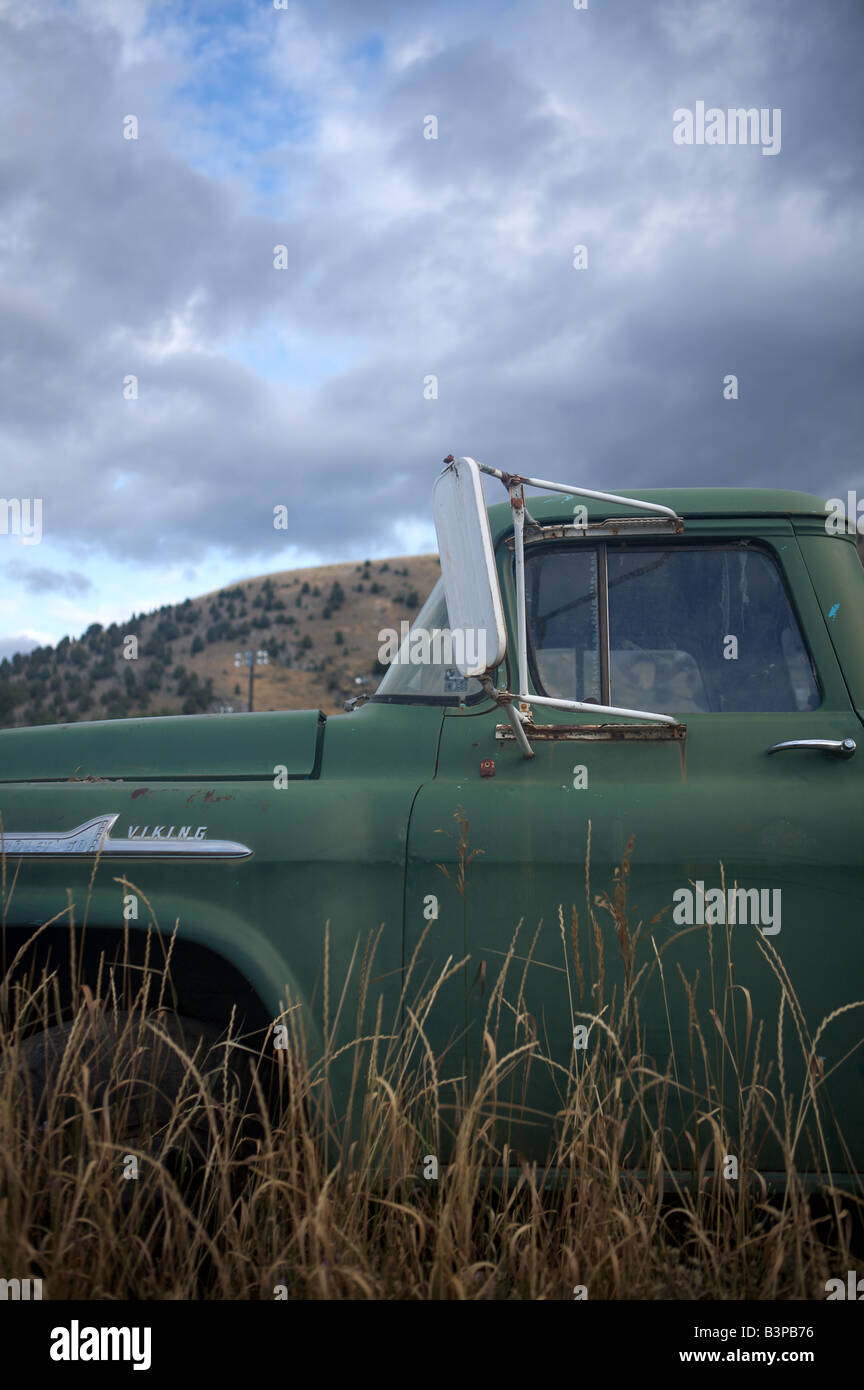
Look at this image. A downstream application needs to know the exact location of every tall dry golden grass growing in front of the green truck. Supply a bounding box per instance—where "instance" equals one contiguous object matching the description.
[0,835,861,1300]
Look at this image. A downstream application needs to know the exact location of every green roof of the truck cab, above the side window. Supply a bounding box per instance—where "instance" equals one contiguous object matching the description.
[489,478,825,542]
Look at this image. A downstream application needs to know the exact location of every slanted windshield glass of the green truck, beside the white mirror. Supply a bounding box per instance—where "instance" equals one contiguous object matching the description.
[374,578,491,702]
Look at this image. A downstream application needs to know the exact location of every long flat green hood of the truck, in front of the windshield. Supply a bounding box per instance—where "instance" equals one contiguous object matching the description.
[0,710,326,783]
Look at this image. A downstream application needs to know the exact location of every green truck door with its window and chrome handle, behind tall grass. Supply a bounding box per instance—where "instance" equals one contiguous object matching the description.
[406,517,864,1170]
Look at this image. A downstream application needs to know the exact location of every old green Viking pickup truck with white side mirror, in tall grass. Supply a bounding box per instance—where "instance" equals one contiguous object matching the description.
[0,457,864,1173]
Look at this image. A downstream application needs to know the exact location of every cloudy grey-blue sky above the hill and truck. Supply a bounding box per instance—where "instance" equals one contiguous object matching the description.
[0,0,864,655]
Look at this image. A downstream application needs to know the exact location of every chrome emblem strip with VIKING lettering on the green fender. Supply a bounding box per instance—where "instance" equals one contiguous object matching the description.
[0,810,251,859]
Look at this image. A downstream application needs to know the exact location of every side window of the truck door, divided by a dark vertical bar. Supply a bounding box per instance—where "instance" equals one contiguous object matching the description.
[531,546,820,714]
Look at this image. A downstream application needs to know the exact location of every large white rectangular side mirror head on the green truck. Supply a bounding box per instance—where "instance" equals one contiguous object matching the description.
[432,459,507,677]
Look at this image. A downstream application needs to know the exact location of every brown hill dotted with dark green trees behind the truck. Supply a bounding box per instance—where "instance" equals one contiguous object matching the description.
[0,555,440,728]
